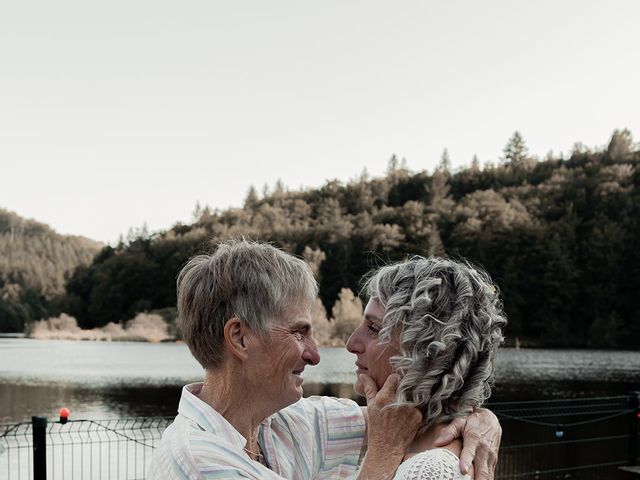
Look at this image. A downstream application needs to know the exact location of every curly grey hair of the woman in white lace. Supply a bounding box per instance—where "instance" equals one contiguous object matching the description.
[364,256,507,432]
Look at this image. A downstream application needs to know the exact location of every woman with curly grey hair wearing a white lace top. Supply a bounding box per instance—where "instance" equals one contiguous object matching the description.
[347,256,507,480]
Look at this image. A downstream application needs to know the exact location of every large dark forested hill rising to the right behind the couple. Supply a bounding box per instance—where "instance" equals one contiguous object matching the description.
[0,130,640,348]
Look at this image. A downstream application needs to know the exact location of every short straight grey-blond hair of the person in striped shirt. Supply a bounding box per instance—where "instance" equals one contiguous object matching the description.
[177,239,318,369]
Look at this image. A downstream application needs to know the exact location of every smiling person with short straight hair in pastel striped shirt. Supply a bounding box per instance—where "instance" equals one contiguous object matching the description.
[149,239,500,480]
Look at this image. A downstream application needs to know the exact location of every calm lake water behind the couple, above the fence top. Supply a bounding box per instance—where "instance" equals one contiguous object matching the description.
[0,338,640,423]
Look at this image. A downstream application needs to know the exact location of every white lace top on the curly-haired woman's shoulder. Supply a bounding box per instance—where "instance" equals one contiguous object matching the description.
[393,448,471,480]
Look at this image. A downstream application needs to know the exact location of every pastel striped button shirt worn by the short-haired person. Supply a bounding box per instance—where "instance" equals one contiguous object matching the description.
[148,383,365,480]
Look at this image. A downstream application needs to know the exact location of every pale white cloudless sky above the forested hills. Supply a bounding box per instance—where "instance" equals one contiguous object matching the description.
[0,0,640,241]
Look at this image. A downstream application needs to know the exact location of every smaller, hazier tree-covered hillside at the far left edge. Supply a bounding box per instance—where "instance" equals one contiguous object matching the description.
[0,208,103,332]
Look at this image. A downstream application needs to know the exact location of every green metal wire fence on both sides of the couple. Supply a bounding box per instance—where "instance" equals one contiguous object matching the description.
[0,392,640,480]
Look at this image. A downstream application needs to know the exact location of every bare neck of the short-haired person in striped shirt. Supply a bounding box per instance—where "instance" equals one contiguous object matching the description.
[198,365,275,452]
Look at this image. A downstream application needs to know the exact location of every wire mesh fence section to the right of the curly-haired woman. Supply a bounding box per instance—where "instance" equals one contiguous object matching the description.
[489,397,633,480]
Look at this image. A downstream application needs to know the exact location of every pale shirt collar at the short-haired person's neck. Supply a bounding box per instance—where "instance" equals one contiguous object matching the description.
[178,382,247,449]
